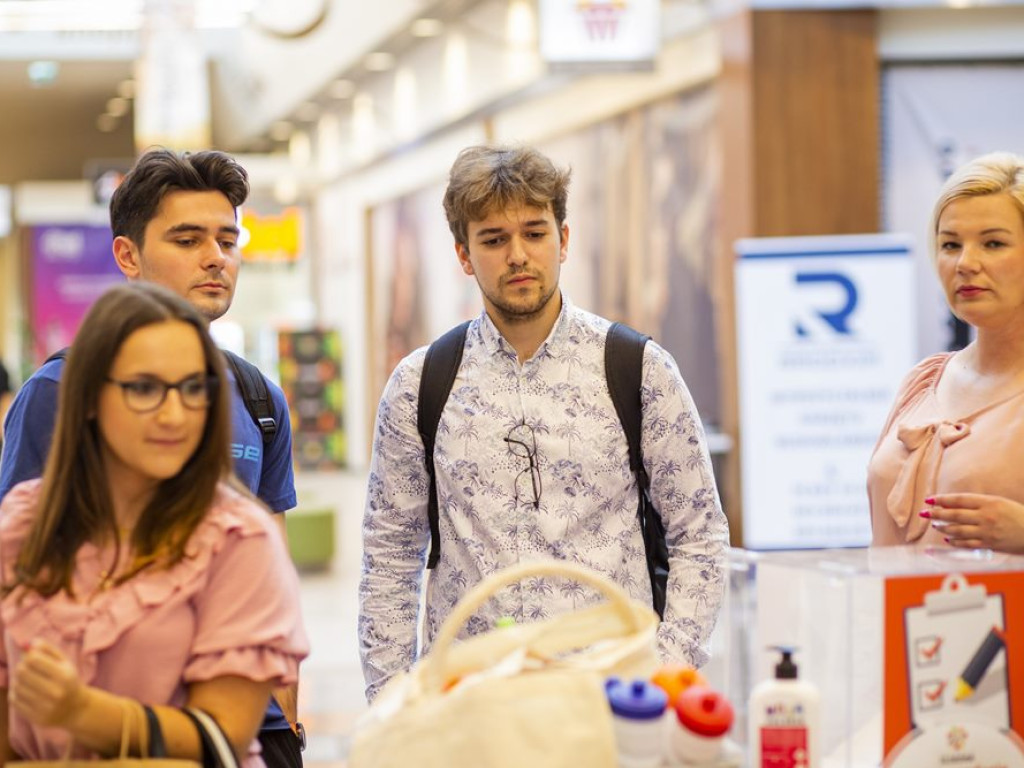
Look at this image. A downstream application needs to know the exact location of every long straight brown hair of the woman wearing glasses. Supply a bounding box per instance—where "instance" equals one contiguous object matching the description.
[12,283,231,597]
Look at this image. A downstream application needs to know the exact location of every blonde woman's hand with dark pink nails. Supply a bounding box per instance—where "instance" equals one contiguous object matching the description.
[921,494,1024,554]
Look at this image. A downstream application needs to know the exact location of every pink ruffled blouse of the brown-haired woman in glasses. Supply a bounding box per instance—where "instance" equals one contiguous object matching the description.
[0,480,309,768]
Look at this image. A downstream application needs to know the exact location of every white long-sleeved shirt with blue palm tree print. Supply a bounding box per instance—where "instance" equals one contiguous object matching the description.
[358,300,728,698]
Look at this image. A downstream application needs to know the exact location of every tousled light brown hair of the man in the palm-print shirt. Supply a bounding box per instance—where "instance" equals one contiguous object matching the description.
[444,145,570,246]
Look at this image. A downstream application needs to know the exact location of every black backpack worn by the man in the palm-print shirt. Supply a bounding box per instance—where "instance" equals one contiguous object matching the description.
[417,322,669,618]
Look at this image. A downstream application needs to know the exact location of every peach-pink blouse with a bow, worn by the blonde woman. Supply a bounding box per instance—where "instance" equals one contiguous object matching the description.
[867,352,1024,546]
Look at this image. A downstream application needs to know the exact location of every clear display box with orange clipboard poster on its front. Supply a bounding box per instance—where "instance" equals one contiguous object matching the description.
[705,547,1024,768]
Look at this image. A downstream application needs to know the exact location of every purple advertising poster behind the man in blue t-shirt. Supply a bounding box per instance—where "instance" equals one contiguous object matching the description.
[31,224,124,365]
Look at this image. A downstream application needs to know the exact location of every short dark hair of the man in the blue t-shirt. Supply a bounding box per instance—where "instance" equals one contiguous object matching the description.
[111,147,249,248]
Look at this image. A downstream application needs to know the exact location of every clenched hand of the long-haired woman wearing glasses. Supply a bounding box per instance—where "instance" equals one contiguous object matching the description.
[9,640,86,726]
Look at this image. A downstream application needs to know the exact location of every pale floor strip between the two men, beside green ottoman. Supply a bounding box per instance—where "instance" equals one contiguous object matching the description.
[296,472,367,768]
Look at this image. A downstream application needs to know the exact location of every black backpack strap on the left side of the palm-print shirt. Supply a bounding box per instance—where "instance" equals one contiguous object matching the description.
[416,321,469,568]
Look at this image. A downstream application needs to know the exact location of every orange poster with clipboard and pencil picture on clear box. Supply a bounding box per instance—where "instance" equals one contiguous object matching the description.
[883,571,1024,768]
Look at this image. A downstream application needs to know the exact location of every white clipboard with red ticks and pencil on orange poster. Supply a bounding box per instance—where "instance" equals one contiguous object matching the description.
[904,573,1011,729]
